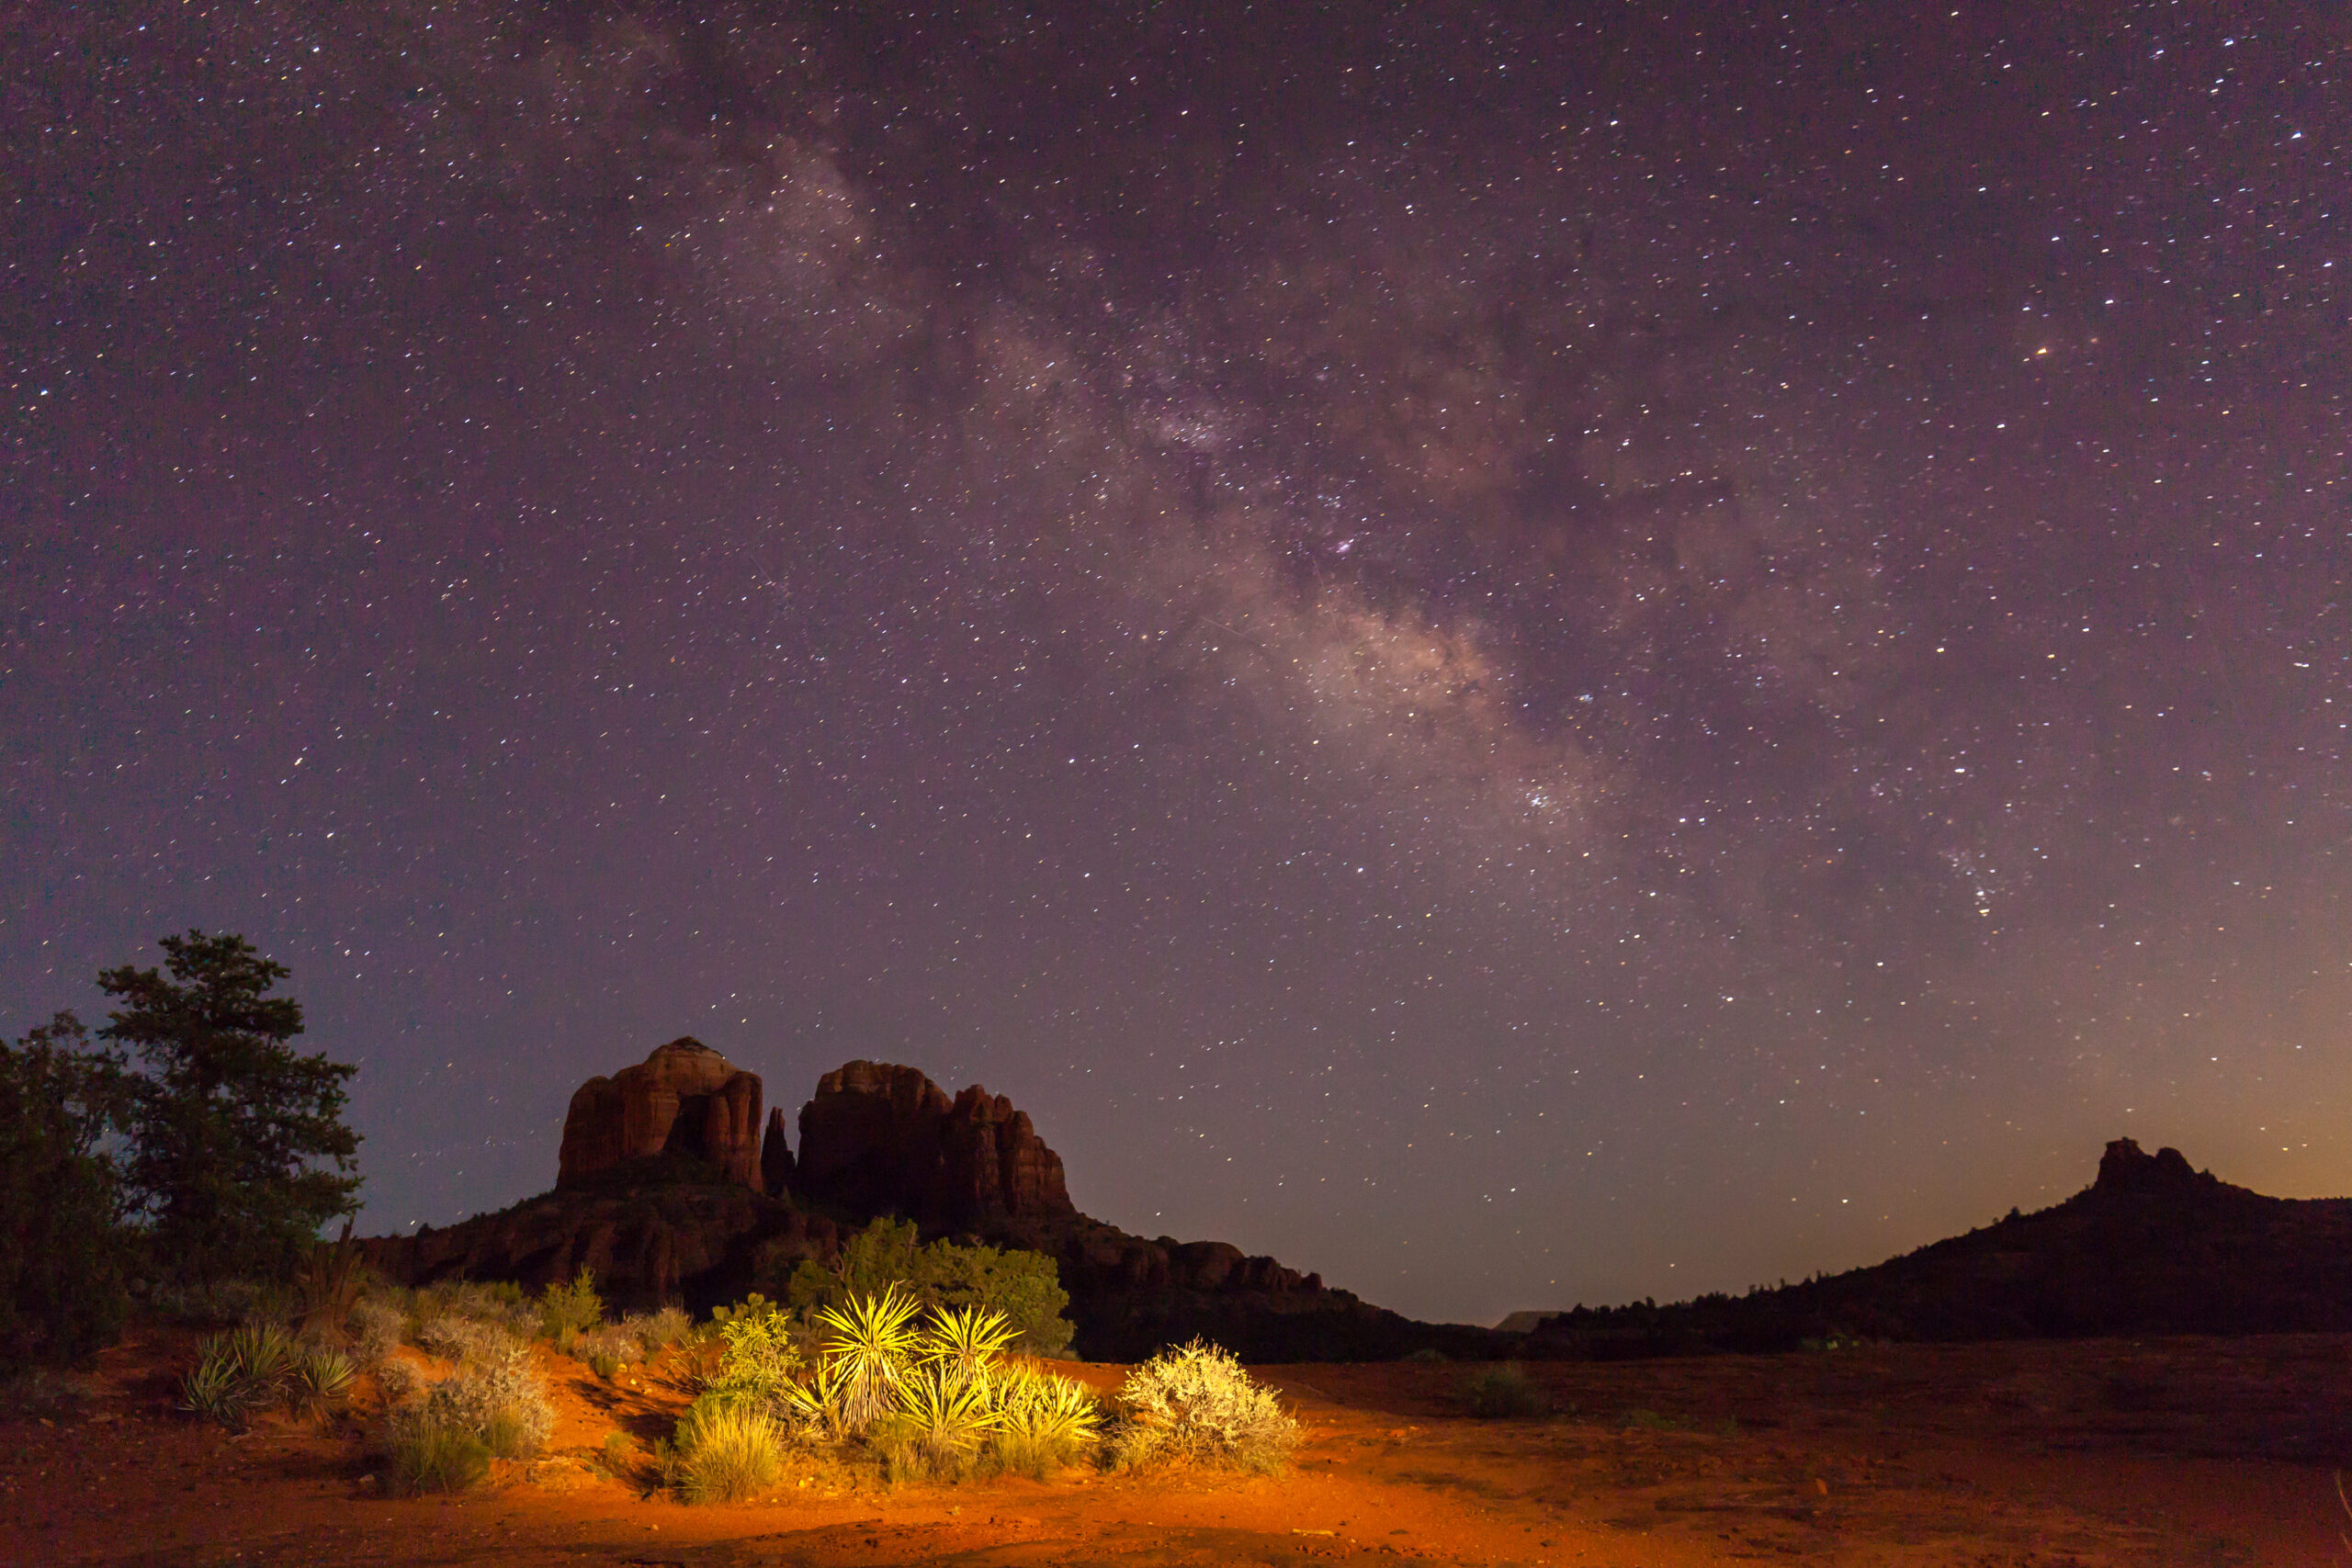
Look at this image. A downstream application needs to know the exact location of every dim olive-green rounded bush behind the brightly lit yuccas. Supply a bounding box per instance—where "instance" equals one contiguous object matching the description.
[786,1218,1075,1357]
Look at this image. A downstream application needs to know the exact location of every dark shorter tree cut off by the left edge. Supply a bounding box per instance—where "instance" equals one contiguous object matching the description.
[0,1013,131,1366]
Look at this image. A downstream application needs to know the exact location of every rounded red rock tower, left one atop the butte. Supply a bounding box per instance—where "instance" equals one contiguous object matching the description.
[555,1039,764,1190]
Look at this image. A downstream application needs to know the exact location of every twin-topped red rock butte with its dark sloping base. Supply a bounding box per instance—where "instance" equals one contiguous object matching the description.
[367,1039,1491,1361]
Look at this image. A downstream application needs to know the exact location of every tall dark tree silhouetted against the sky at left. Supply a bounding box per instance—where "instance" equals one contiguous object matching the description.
[99,931,360,1279]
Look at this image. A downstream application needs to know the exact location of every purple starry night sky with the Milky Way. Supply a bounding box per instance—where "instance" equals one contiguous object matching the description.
[0,0,2352,1319]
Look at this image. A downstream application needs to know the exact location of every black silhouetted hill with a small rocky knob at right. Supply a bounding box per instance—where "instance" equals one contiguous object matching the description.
[1524,1138,2352,1359]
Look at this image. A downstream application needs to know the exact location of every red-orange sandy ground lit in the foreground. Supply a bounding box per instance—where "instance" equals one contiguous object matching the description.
[0,1331,2352,1568]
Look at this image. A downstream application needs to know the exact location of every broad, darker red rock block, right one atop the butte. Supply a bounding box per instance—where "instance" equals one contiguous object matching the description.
[795,1063,1077,1224]
